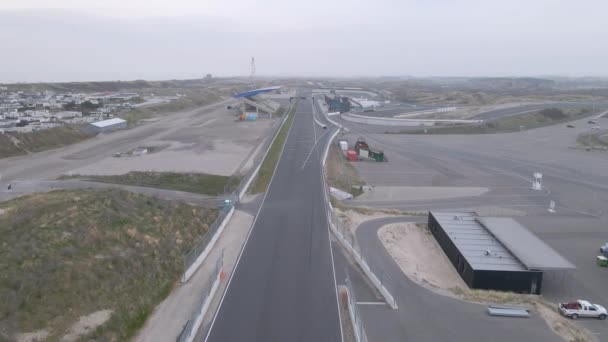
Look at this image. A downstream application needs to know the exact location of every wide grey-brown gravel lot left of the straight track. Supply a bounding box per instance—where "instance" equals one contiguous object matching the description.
[0,100,279,184]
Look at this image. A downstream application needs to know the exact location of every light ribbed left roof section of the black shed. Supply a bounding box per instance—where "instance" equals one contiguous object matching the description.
[431,212,527,271]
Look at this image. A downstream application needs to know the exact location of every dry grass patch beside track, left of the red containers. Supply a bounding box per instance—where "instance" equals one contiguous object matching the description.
[327,143,365,197]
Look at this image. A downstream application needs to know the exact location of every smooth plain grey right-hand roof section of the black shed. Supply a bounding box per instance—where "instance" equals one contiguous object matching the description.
[477,217,576,270]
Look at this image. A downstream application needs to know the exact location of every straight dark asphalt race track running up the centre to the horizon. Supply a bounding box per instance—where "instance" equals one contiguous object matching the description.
[206,99,342,342]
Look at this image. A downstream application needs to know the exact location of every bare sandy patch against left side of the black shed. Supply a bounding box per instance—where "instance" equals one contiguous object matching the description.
[378,223,467,289]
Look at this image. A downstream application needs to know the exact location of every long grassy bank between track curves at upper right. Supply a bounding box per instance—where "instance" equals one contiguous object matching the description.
[399,108,592,134]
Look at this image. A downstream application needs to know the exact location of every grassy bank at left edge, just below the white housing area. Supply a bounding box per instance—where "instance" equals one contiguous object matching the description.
[0,125,95,158]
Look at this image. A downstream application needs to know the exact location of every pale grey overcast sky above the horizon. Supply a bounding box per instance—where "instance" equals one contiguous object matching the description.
[0,0,608,82]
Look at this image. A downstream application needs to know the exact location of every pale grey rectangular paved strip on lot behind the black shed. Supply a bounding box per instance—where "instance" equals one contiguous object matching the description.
[357,186,488,201]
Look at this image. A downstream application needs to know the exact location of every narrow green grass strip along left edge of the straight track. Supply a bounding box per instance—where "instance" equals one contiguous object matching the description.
[249,100,298,194]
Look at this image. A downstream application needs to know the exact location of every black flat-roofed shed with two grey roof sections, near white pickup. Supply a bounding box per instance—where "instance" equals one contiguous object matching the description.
[428,212,574,294]
